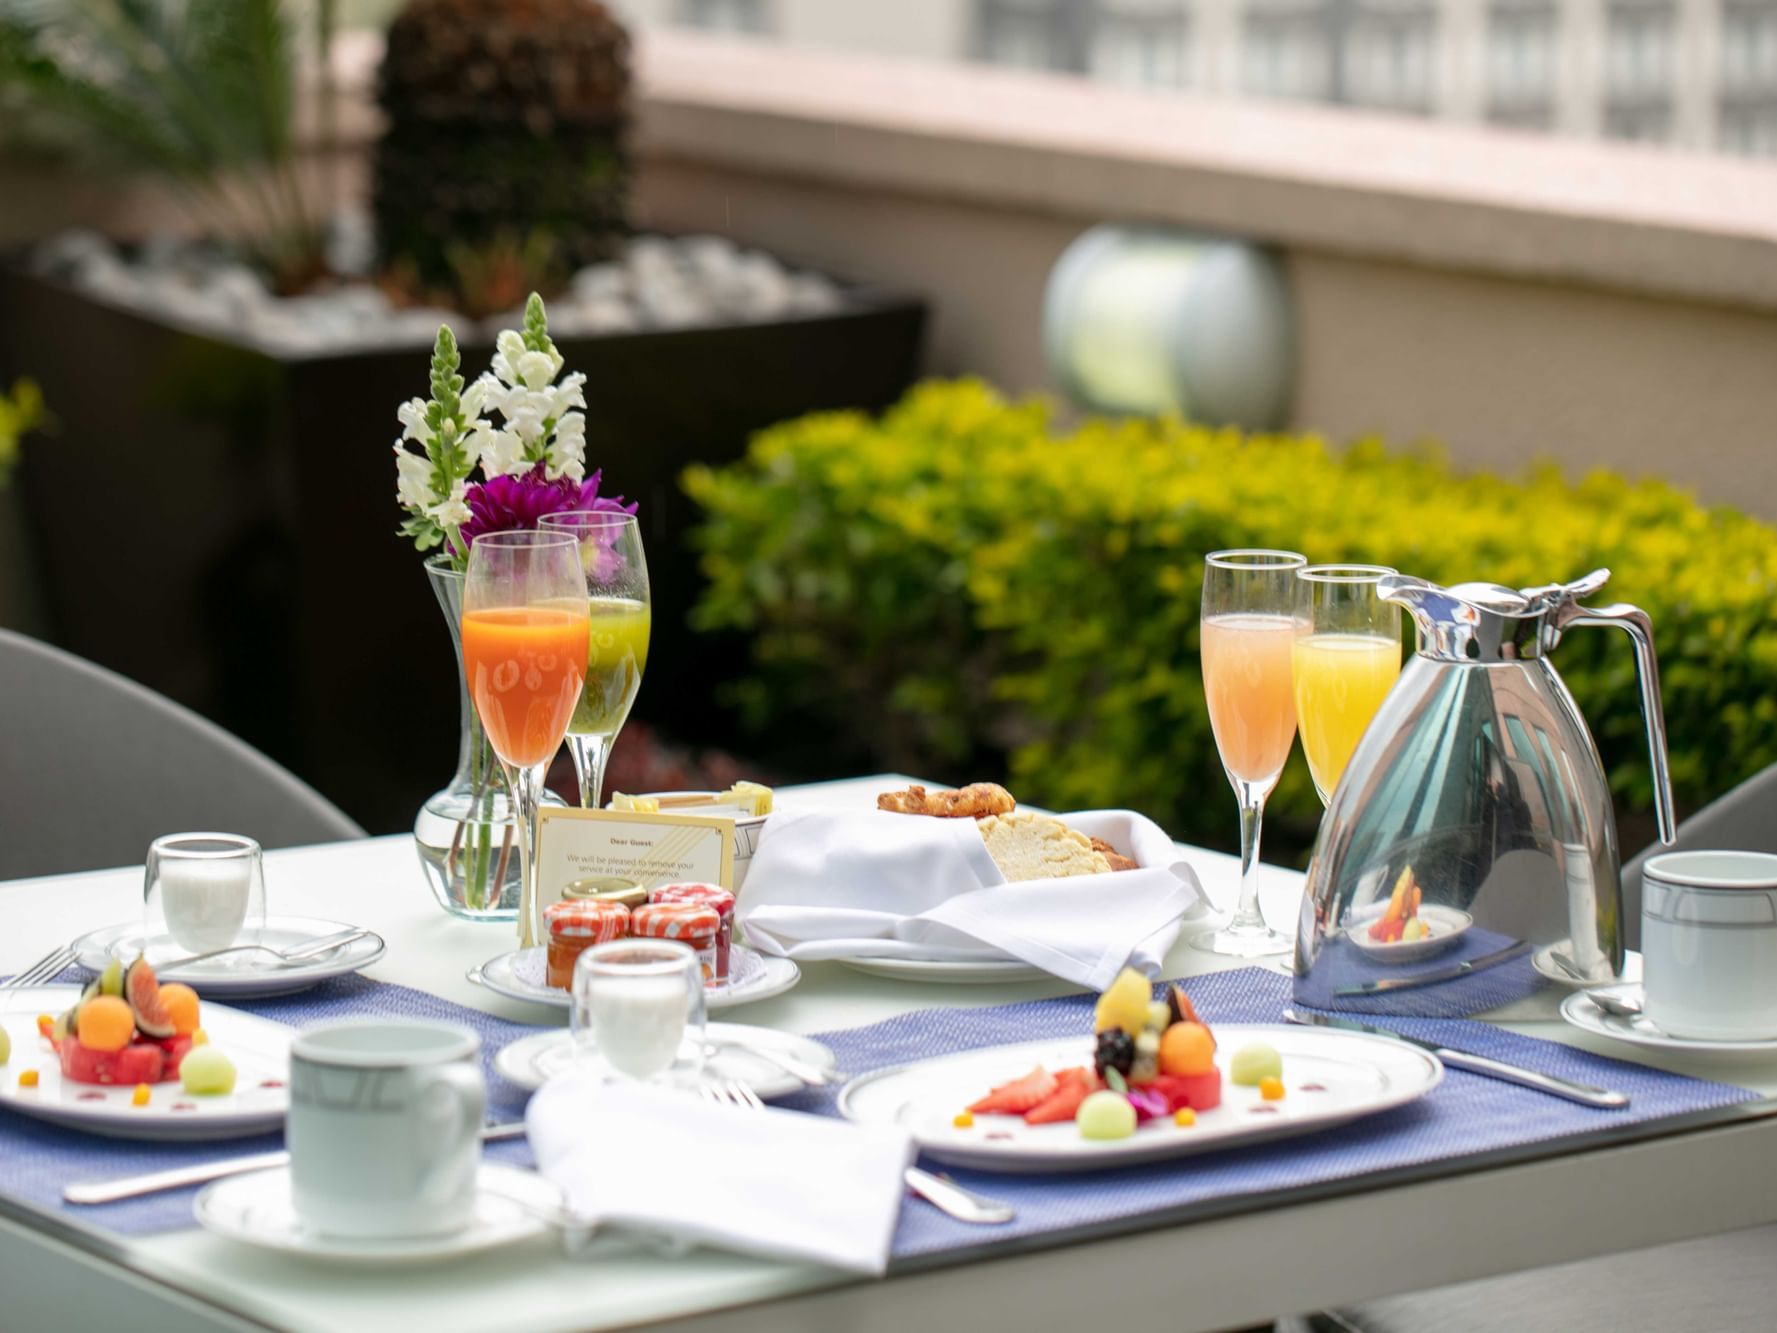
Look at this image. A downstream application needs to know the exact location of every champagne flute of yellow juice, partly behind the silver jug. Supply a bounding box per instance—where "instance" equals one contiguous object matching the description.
[1294,565,1400,805]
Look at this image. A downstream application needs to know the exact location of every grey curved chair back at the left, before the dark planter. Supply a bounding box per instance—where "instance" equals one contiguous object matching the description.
[0,629,364,880]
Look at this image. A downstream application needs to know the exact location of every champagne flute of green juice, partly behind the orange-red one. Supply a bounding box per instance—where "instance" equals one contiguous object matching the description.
[537,510,650,810]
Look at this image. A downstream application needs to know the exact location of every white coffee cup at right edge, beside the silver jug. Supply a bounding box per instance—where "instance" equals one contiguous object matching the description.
[1642,851,1777,1042]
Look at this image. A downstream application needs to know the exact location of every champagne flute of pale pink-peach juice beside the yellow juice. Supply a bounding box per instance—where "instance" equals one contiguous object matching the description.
[1191,549,1308,958]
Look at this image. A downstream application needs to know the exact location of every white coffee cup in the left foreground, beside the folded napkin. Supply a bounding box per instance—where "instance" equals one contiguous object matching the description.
[284,1018,487,1237]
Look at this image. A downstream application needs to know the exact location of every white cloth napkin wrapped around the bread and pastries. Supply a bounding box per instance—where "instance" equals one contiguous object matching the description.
[736,810,1203,990]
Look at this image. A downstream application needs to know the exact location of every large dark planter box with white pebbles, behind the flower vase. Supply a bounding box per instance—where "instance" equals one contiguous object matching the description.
[0,267,924,832]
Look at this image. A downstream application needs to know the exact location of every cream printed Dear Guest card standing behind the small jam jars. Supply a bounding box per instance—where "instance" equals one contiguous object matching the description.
[537,807,734,906]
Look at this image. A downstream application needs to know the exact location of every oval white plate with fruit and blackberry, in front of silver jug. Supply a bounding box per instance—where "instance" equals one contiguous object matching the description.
[839,970,1443,1171]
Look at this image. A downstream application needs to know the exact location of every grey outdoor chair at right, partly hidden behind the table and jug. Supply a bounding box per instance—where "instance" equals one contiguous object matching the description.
[1278,764,1777,1333]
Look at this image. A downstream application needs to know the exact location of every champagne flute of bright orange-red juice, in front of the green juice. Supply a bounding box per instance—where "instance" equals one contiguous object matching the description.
[462,530,588,949]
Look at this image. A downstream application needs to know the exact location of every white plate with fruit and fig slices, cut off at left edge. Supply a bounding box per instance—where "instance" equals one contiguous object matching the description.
[0,963,295,1139]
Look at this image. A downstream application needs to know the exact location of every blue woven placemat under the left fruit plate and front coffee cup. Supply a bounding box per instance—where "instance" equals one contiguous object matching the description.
[0,972,537,1235]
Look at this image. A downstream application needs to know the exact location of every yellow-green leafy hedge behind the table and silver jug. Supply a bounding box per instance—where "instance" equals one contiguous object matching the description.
[684,380,1777,856]
